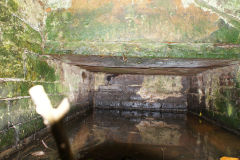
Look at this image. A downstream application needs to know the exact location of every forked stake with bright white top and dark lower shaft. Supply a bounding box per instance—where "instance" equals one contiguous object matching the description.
[29,85,73,160]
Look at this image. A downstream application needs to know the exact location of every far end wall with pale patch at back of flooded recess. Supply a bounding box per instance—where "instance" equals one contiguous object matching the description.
[94,73,188,111]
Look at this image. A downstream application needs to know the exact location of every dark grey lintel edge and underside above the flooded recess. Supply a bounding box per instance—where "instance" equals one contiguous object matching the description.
[50,55,240,75]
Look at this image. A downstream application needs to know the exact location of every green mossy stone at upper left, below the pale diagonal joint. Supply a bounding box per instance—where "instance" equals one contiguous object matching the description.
[0,2,41,53]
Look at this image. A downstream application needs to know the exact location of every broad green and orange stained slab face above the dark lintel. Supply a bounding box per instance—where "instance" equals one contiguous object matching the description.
[46,0,240,56]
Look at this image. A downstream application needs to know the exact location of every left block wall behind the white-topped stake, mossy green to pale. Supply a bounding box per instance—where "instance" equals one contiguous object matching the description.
[0,57,93,157]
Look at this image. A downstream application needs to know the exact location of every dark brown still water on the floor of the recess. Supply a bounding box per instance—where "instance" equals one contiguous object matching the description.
[6,110,240,160]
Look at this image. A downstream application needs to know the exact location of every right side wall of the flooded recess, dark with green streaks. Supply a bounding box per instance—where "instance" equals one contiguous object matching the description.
[187,65,240,133]
